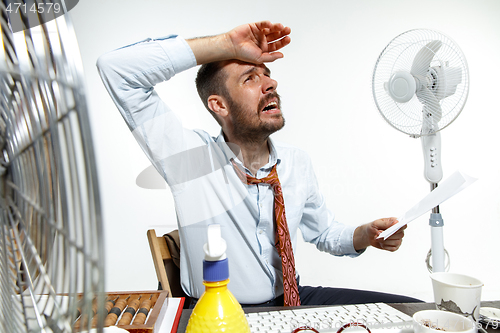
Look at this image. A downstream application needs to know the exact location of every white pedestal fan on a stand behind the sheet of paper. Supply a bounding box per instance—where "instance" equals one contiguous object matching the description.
[372,29,469,272]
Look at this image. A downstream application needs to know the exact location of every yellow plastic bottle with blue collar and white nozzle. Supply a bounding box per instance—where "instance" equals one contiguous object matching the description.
[186,224,250,333]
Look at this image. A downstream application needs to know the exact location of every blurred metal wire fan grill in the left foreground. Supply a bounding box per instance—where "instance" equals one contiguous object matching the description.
[0,1,104,333]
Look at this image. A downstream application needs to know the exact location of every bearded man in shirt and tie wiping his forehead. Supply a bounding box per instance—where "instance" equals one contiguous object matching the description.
[97,21,413,305]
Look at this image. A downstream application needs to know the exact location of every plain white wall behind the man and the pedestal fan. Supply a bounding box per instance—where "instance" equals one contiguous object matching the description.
[71,0,500,301]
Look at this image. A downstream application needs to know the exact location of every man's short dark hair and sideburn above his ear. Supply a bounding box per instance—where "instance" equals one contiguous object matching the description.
[195,61,230,125]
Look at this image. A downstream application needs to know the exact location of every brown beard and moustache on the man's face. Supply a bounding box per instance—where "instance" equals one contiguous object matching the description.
[226,92,285,143]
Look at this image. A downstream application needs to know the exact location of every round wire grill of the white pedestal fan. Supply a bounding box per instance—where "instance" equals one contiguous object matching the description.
[372,29,469,138]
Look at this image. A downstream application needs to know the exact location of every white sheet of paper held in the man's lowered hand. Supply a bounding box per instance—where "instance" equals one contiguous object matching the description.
[377,171,477,240]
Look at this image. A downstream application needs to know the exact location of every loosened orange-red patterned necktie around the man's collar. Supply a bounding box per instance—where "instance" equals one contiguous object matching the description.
[233,161,300,306]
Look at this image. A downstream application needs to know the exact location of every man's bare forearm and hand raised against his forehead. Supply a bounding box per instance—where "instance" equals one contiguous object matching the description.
[187,21,291,65]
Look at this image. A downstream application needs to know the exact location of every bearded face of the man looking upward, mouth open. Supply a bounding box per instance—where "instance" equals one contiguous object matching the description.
[224,61,285,142]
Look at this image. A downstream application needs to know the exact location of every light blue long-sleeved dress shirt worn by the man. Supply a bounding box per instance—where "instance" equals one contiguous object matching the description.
[97,36,358,304]
